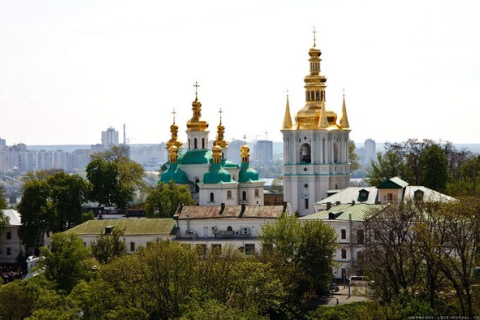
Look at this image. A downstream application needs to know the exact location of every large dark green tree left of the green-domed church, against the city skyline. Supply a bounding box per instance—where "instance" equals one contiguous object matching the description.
[86,146,145,208]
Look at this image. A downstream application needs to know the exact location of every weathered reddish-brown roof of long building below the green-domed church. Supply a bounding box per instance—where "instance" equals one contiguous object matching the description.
[175,205,293,220]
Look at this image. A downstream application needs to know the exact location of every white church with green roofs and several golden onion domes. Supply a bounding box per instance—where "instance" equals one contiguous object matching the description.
[159,84,265,206]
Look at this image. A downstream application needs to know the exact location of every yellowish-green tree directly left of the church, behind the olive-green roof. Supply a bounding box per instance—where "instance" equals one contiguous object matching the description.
[145,181,195,218]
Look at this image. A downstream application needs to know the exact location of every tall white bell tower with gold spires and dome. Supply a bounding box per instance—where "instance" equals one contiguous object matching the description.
[281,39,350,216]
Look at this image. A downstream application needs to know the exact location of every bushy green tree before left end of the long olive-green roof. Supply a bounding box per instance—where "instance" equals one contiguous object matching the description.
[40,233,93,293]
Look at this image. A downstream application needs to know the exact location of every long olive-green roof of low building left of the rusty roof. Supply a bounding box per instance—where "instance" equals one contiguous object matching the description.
[65,218,177,236]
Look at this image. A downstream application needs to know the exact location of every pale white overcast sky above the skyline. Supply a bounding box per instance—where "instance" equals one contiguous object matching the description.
[0,0,480,145]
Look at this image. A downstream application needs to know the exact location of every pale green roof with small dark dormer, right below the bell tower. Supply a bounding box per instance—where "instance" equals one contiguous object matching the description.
[300,204,385,221]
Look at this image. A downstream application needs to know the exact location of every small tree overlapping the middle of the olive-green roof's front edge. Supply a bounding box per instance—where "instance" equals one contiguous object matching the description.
[90,228,127,264]
